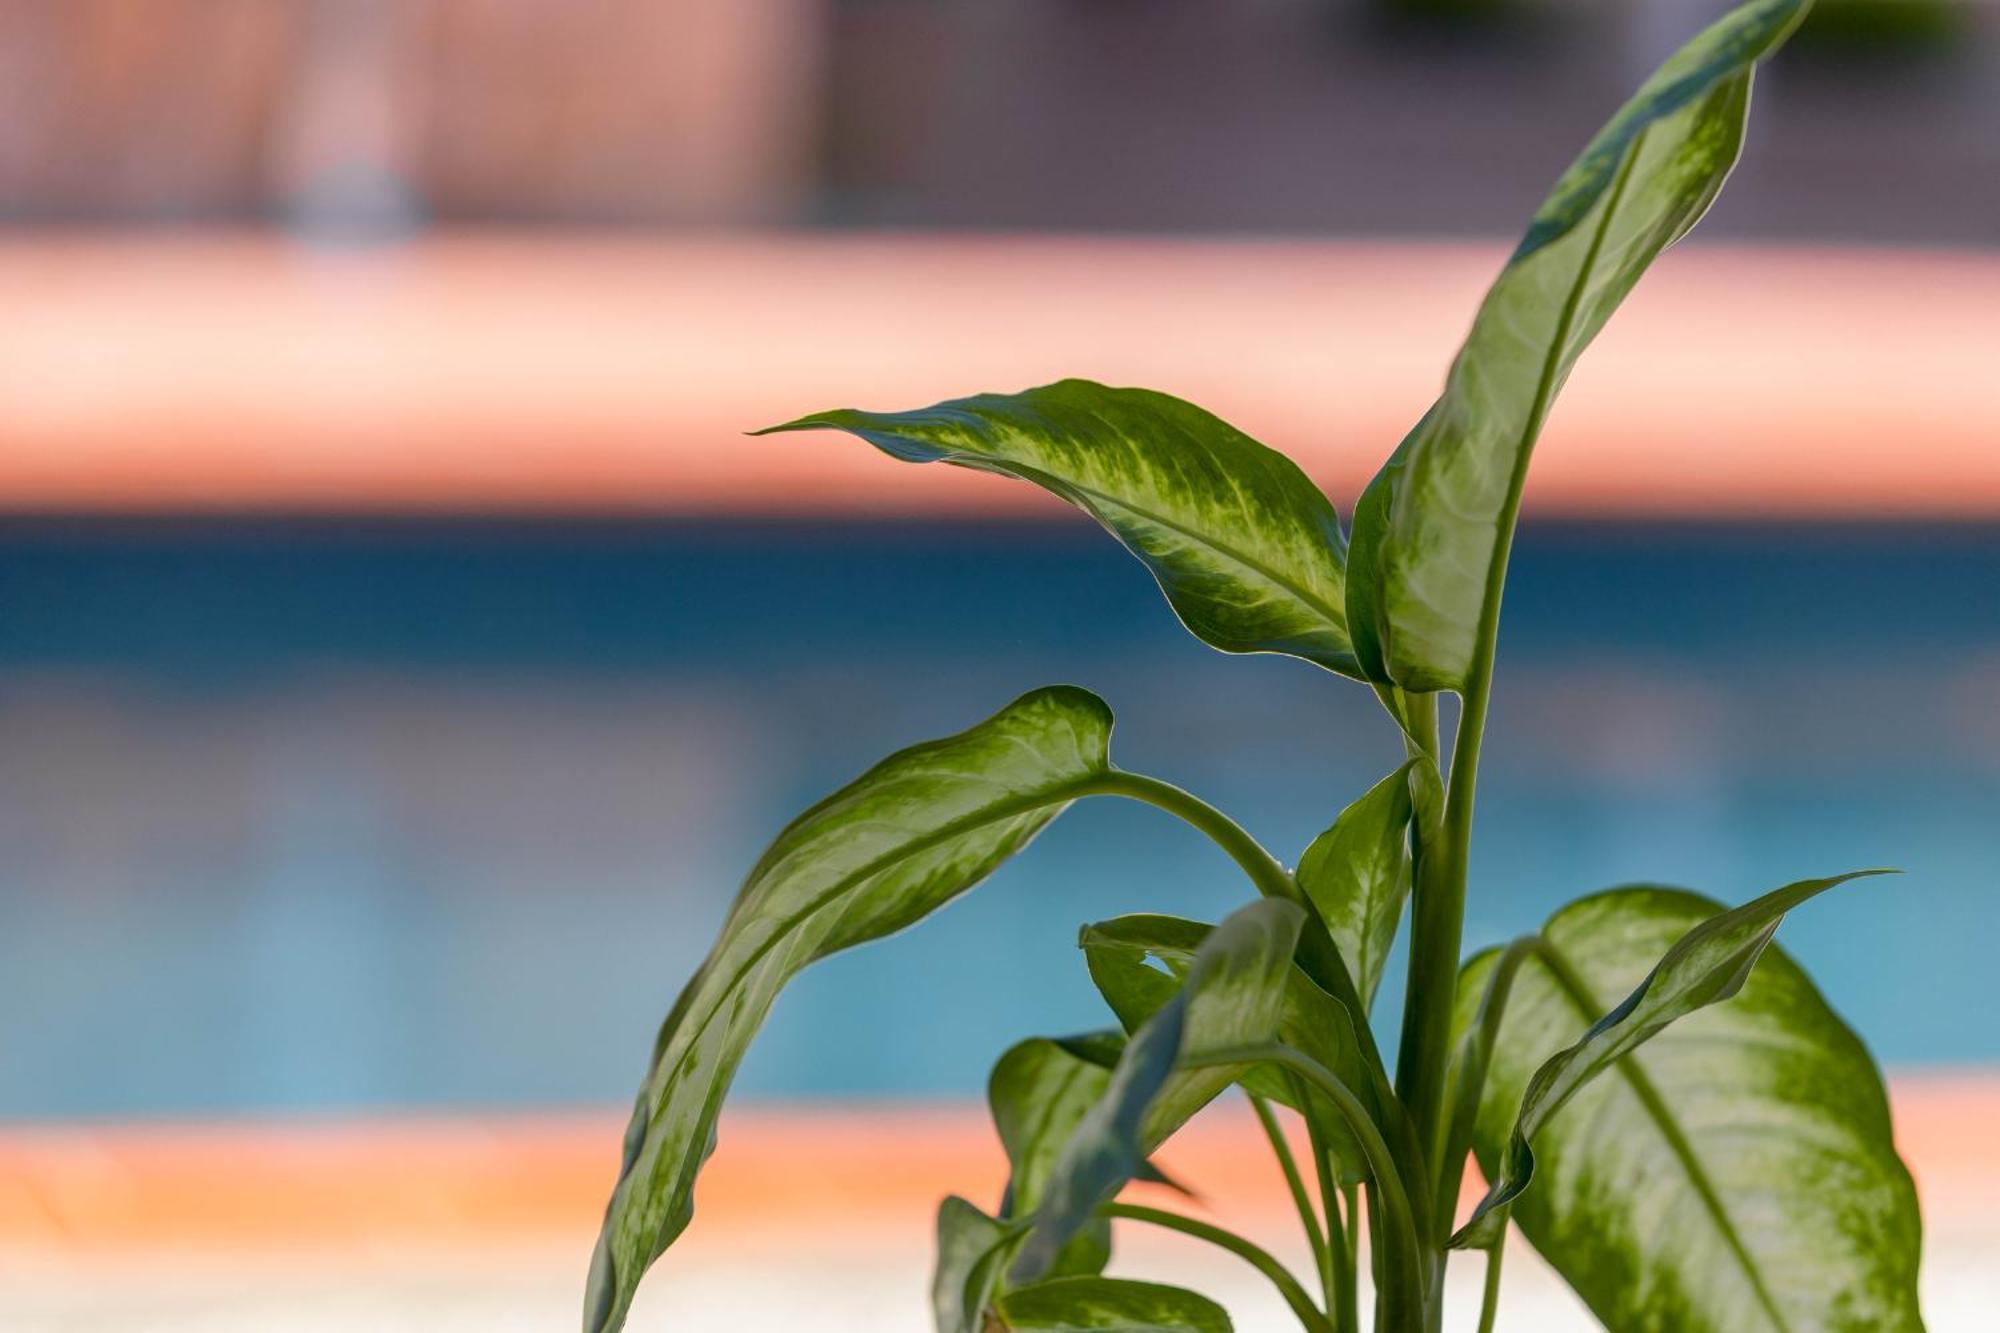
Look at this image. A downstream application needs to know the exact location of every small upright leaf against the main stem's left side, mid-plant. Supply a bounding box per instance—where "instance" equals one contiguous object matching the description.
[1294,761,1420,1008]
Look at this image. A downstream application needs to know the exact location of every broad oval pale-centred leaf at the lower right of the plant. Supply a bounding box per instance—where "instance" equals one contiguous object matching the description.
[1460,881,1922,1333]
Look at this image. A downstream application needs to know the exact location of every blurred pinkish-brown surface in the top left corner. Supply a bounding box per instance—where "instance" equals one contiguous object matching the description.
[0,0,826,228]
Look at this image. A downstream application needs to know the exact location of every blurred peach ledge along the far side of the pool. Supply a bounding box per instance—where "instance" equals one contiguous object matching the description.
[0,232,2000,518]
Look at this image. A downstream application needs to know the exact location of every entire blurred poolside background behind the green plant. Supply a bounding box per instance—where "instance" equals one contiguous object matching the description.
[0,0,2000,1329]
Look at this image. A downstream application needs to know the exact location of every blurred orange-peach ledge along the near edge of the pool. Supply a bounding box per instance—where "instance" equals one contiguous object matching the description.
[0,1073,2000,1267]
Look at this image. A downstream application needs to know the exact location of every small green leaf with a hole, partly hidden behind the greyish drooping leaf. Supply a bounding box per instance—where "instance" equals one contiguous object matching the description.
[1080,913,1388,1185]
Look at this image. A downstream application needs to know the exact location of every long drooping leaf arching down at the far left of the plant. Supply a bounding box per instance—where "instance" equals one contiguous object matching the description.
[584,687,1112,1333]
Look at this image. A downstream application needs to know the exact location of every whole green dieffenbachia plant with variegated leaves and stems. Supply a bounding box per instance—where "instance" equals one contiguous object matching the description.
[584,0,1922,1333]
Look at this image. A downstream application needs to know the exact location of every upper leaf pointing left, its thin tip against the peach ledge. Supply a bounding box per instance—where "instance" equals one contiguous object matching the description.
[758,380,1360,677]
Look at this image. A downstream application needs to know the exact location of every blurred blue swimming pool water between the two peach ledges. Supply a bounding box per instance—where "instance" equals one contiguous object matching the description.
[0,520,2000,1117]
